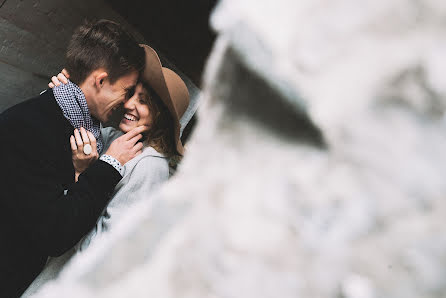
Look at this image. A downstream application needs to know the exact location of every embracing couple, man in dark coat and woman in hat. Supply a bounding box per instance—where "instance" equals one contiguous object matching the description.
[0,20,189,297]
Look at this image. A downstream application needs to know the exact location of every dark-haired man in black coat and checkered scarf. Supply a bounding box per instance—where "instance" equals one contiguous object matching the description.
[0,20,144,297]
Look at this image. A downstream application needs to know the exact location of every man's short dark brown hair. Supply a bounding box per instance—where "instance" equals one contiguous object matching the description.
[66,20,145,85]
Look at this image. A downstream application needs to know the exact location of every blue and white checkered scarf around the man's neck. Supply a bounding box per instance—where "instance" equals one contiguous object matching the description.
[53,81,104,154]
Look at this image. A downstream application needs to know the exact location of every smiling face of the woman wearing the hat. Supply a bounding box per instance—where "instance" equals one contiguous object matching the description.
[119,83,152,133]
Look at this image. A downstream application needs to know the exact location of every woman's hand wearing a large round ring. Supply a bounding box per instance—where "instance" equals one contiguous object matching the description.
[70,127,99,182]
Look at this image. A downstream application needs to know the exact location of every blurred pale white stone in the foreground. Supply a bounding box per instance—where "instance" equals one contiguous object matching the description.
[26,0,446,298]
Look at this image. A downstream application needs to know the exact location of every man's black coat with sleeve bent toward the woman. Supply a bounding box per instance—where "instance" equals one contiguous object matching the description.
[0,90,121,297]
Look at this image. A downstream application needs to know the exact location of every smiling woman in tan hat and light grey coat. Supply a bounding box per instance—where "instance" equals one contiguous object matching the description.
[24,45,189,297]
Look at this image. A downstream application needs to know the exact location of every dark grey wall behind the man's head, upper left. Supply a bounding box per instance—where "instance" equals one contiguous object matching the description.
[0,0,143,111]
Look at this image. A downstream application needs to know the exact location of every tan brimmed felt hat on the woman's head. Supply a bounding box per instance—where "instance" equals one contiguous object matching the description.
[140,45,189,154]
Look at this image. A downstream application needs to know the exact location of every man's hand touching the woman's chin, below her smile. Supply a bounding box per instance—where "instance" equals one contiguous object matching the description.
[105,126,148,165]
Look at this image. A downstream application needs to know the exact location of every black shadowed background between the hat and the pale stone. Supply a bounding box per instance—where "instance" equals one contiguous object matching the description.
[106,0,220,87]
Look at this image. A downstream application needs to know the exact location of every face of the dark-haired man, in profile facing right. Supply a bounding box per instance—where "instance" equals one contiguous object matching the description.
[91,70,138,123]
